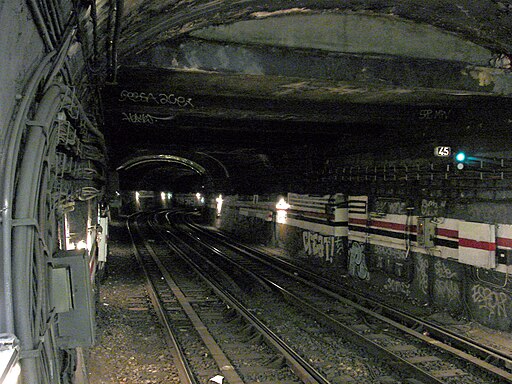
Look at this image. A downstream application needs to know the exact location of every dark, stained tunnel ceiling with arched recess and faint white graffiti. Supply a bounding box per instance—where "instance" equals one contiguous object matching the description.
[94,0,512,192]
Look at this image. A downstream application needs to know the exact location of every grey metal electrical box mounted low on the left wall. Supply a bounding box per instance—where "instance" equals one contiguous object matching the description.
[49,250,95,349]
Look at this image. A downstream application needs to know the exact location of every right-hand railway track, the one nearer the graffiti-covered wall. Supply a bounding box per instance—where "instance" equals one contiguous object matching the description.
[162,212,512,384]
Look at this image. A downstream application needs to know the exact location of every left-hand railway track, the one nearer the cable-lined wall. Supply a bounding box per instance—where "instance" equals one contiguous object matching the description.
[129,216,329,384]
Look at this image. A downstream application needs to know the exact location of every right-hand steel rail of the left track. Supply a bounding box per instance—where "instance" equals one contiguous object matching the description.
[152,212,329,384]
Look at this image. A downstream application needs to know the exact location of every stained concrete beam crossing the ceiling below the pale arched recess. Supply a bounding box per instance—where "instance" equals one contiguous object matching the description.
[127,39,512,99]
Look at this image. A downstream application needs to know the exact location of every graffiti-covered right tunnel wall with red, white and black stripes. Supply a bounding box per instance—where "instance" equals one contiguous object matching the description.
[210,193,512,331]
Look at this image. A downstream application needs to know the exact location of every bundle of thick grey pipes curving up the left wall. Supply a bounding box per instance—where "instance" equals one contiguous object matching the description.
[9,84,104,384]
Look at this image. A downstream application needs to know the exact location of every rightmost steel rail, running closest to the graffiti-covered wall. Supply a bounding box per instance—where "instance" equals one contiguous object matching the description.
[183,218,512,382]
